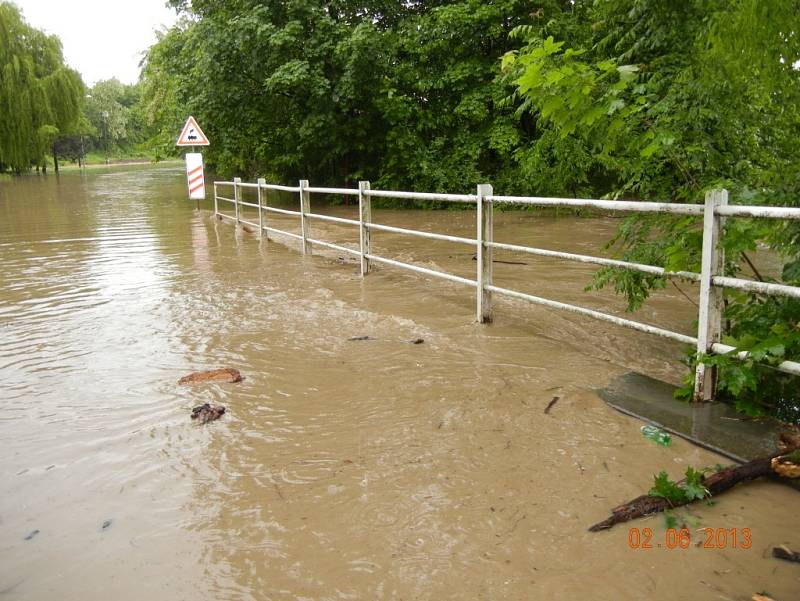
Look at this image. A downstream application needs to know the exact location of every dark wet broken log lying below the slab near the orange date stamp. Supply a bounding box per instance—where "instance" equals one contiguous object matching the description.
[589,441,797,532]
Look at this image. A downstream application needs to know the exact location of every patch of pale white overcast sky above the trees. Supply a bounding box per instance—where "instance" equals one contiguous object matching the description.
[12,0,176,86]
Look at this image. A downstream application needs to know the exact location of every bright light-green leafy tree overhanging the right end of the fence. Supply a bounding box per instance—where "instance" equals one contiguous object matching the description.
[503,0,800,420]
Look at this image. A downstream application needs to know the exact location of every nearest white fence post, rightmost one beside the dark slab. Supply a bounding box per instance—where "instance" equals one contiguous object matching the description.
[694,190,728,402]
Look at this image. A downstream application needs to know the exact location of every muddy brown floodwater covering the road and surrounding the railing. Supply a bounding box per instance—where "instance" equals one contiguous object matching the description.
[0,167,800,601]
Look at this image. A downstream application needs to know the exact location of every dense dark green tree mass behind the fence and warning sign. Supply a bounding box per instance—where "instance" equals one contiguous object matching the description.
[139,0,572,190]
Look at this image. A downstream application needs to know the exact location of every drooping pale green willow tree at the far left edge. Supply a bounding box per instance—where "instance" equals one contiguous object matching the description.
[0,2,83,172]
